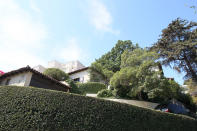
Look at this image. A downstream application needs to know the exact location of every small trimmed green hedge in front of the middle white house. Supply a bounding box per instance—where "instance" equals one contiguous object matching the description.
[77,82,107,94]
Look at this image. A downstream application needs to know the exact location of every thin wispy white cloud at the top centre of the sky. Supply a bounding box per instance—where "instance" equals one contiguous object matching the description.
[88,0,120,35]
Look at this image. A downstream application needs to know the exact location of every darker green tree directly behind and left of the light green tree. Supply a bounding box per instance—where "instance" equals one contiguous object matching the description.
[90,40,139,84]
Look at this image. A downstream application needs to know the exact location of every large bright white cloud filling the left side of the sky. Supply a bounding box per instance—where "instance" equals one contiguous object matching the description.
[0,0,47,71]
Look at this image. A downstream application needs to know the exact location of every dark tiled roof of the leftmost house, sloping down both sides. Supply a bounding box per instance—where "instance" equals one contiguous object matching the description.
[0,66,71,88]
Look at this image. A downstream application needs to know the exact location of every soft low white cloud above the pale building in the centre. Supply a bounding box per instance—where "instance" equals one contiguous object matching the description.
[59,38,88,61]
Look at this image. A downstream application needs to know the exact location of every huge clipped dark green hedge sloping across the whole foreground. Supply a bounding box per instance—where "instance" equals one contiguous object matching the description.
[0,87,197,131]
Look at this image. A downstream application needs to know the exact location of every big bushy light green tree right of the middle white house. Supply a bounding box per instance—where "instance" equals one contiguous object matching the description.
[110,49,163,99]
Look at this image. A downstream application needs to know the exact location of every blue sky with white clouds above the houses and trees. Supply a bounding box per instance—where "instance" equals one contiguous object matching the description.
[0,0,197,84]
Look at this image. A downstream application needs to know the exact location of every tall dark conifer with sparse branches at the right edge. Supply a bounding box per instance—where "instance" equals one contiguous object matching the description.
[150,18,197,81]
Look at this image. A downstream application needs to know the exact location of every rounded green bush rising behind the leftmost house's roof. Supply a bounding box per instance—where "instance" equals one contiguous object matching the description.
[43,68,69,81]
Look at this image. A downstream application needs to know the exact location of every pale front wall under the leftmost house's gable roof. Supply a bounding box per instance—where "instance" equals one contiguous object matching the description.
[0,72,32,86]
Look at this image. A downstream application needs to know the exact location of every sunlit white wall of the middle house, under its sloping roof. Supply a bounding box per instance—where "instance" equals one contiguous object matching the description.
[69,70,90,83]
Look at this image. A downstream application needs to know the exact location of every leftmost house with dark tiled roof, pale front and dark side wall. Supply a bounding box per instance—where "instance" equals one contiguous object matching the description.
[0,66,71,92]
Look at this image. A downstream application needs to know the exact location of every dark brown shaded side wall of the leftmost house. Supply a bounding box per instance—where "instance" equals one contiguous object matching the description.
[29,74,68,92]
